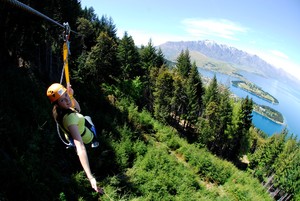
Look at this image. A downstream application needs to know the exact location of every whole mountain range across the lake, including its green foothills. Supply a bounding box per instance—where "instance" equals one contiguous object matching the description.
[158,40,300,85]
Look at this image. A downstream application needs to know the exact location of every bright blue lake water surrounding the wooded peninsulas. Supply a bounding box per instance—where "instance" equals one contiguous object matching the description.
[198,68,300,138]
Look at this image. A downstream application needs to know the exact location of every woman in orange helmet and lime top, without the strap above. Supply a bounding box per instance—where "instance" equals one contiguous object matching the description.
[47,83,103,194]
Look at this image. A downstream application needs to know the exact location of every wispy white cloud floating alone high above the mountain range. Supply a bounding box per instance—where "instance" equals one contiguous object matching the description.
[182,18,248,40]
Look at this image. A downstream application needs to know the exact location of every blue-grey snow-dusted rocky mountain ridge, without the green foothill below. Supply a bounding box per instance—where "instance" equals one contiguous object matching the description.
[159,40,293,85]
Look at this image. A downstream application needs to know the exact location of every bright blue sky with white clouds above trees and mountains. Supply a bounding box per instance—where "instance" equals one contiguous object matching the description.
[81,0,300,79]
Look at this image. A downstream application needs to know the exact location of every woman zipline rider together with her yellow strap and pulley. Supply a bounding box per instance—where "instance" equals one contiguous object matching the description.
[47,23,103,194]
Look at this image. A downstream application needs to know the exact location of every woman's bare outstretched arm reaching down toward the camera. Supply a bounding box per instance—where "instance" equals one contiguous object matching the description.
[68,125,102,193]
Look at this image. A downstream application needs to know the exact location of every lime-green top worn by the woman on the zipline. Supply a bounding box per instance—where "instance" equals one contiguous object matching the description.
[63,112,94,144]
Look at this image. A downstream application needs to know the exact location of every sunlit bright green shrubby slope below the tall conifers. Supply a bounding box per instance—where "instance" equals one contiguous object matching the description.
[100,105,272,201]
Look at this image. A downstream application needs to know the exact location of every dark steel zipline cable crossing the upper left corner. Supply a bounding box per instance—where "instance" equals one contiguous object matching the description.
[0,0,81,35]
